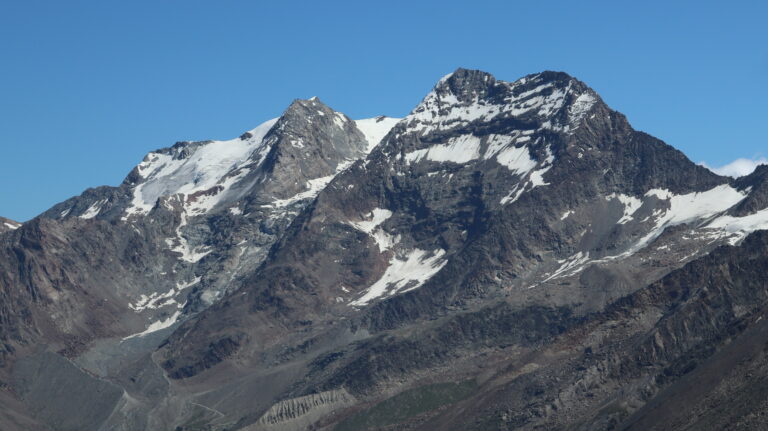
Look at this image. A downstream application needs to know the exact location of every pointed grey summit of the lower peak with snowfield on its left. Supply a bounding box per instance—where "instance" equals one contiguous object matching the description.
[115,97,376,217]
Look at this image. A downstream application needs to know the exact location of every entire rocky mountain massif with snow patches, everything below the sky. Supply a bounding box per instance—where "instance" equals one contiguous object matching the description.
[0,69,768,430]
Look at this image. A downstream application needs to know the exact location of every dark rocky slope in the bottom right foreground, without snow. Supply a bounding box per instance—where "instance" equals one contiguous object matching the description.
[415,232,768,430]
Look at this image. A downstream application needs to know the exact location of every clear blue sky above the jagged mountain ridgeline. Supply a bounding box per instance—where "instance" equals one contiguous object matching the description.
[0,0,768,221]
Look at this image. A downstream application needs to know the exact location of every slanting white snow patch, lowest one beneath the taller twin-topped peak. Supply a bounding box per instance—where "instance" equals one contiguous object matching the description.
[350,249,447,306]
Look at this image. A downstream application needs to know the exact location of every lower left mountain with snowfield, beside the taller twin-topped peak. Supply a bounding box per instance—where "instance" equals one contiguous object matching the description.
[3,99,394,349]
